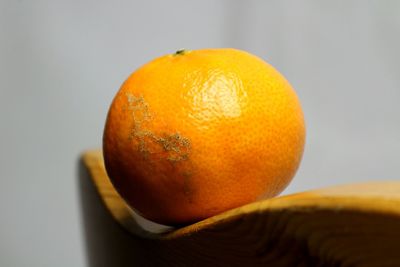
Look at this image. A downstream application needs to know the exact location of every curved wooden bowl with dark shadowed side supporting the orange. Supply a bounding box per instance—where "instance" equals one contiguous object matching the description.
[79,151,400,267]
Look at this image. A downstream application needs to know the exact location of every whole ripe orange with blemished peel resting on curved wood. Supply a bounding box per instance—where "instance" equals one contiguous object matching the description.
[103,49,305,225]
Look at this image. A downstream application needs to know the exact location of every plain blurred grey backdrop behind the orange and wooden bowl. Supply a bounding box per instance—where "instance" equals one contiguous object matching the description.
[0,0,400,267]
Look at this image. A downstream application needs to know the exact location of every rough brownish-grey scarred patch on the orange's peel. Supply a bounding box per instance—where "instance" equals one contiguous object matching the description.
[124,93,192,202]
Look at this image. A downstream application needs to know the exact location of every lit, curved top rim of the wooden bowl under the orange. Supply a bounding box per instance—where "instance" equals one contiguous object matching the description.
[82,150,400,240]
